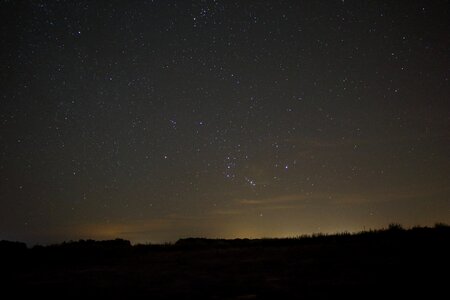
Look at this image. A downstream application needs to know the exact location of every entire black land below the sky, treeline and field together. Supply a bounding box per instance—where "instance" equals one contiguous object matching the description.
[0,225,450,299]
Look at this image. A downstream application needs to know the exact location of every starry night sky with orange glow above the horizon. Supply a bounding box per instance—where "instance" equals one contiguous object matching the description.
[0,0,450,244]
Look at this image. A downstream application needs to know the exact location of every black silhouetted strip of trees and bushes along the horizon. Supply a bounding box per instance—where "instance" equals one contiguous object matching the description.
[0,223,450,254]
